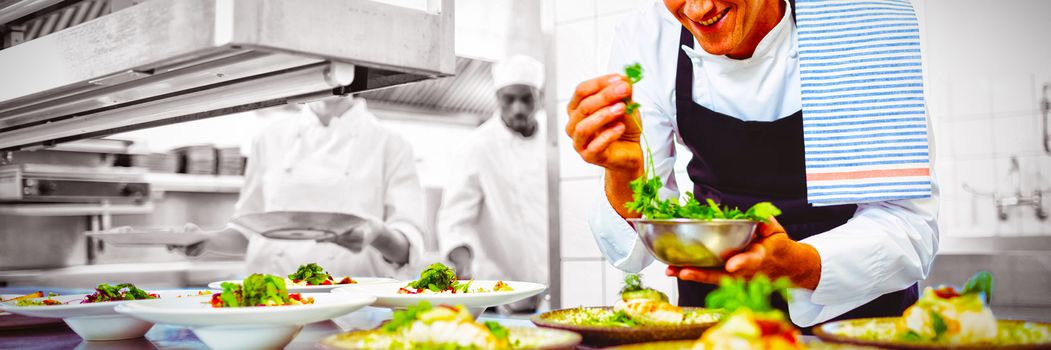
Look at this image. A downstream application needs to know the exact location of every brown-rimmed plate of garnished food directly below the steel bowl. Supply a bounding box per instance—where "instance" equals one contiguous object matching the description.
[532,273,722,347]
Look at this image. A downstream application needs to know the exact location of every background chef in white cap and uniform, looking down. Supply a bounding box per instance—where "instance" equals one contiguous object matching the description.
[437,55,548,284]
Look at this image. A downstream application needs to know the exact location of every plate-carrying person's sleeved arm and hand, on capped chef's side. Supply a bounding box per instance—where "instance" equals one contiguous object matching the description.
[371,135,424,266]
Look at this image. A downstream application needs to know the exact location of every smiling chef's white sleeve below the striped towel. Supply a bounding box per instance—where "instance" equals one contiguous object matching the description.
[788,132,939,327]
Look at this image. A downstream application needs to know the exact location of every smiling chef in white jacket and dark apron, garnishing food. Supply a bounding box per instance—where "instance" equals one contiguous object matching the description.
[565,0,939,327]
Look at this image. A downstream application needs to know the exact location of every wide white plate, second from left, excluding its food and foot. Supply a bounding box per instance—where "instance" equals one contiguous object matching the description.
[117,293,375,327]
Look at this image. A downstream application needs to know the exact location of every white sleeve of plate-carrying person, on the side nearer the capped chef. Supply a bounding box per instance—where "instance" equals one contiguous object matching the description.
[384,133,424,267]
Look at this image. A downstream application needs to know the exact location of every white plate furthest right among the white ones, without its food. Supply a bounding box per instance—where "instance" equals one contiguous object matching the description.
[332,281,548,309]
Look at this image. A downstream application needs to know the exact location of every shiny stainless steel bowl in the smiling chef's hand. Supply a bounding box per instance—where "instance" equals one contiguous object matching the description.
[628,219,759,267]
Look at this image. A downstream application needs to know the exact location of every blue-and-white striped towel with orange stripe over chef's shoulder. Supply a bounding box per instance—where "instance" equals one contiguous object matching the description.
[796,0,931,205]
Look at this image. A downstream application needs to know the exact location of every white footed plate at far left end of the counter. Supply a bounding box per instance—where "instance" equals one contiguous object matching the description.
[0,291,187,341]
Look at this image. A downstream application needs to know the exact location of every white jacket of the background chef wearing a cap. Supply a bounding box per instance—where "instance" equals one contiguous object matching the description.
[437,112,548,284]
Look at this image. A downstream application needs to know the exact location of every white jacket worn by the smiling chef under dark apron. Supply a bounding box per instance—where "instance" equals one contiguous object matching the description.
[589,1,939,327]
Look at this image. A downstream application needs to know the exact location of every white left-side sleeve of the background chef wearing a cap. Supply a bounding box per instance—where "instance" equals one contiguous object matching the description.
[437,143,483,259]
